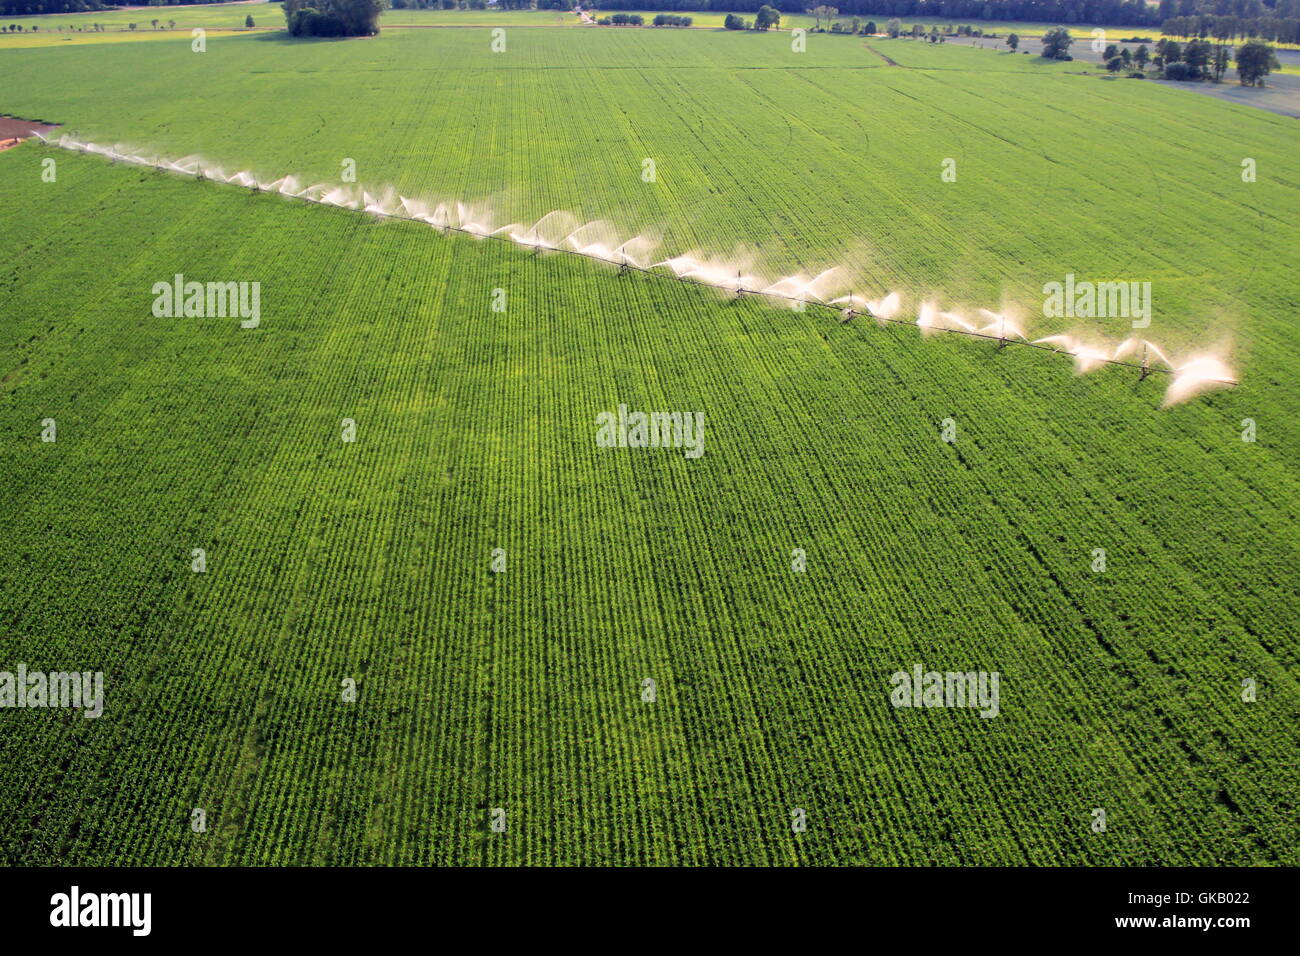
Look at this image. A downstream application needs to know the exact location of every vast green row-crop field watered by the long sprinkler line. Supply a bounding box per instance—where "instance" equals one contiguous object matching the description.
[0,14,1300,865]
